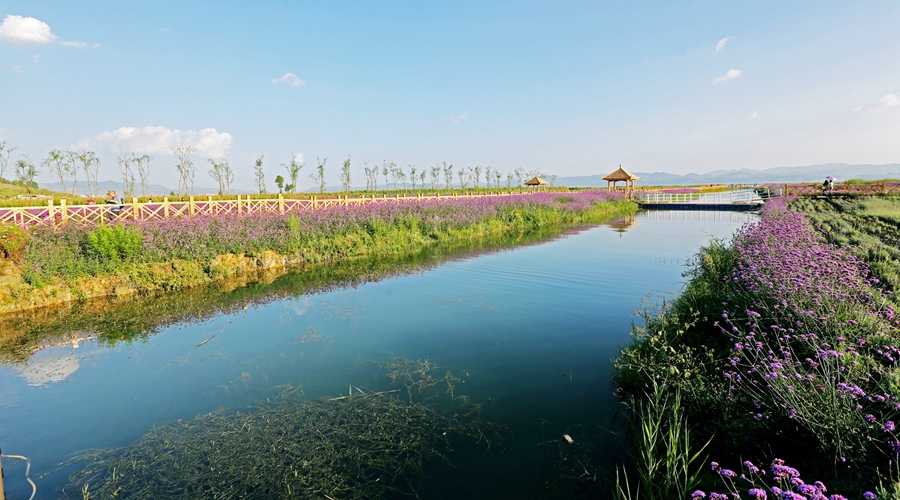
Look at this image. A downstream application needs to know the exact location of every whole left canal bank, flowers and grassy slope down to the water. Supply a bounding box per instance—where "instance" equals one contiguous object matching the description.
[0,192,636,315]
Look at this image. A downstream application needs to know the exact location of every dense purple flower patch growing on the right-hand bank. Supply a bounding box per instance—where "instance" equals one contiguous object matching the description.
[720,201,900,462]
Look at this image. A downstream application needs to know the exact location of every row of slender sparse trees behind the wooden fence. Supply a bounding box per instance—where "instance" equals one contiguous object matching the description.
[0,141,555,198]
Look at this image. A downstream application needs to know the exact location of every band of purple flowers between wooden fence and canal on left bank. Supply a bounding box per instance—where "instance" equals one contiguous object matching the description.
[19,191,623,281]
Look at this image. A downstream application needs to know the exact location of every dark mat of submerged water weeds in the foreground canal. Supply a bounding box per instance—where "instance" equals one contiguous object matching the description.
[66,360,494,499]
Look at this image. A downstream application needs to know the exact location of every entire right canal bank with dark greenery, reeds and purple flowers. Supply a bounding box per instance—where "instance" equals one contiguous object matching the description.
[616,198,900,498]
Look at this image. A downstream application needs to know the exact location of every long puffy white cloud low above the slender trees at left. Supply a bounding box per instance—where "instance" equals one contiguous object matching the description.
[84,126,233,158]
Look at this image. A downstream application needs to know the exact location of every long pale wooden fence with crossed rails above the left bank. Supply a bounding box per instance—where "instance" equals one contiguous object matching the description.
[0,191,564,227]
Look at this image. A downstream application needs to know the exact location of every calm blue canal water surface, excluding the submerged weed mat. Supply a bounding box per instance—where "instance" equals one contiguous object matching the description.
[0,212,753,499]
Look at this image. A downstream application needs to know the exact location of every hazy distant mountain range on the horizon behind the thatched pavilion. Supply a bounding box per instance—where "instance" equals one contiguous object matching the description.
[556,163,900,187]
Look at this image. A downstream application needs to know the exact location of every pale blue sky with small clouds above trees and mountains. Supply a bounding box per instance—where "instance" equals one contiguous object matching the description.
[0,0,900,189]
